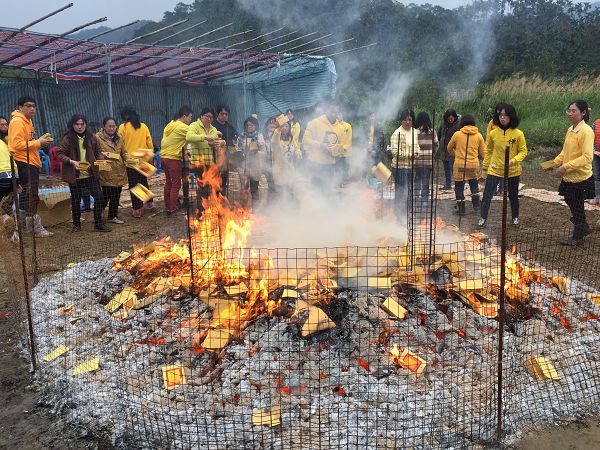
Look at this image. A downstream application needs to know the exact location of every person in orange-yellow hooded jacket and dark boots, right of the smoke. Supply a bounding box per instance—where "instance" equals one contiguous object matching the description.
[448,114,485,216]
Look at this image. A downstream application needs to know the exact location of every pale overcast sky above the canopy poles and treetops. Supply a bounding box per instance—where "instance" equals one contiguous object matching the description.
[0,0,592,34]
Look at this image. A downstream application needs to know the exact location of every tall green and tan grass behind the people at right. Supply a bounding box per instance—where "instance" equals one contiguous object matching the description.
[455,74,600,149]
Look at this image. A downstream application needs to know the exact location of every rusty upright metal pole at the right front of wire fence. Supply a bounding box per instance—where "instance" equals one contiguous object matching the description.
[496,145,510,443]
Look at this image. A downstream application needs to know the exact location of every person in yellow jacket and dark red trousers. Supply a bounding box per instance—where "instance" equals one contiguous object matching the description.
[160,106,200,216]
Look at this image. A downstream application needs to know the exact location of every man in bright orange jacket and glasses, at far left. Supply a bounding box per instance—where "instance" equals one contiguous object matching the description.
[8,96,54,237]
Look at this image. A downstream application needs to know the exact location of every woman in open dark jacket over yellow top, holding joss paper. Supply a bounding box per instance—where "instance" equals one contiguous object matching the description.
[56,114,110,233]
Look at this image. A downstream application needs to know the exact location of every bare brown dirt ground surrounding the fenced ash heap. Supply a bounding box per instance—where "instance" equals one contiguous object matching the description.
[0,163,600,449]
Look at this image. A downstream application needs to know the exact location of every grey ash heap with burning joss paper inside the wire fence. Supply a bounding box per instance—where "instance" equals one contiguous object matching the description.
[32,243,600,449]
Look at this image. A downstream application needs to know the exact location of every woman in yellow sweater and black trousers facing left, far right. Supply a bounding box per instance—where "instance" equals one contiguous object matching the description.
[554,100,595,245]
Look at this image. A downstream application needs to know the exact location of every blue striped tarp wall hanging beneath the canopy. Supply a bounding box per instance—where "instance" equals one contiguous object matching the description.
[0,59,337,141]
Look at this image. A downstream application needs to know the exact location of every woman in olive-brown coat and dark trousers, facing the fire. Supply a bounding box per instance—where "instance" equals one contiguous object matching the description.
[96,117,132,224]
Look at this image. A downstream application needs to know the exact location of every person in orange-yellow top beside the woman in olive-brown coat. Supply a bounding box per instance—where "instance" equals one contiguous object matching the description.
[118,106,154,219]
